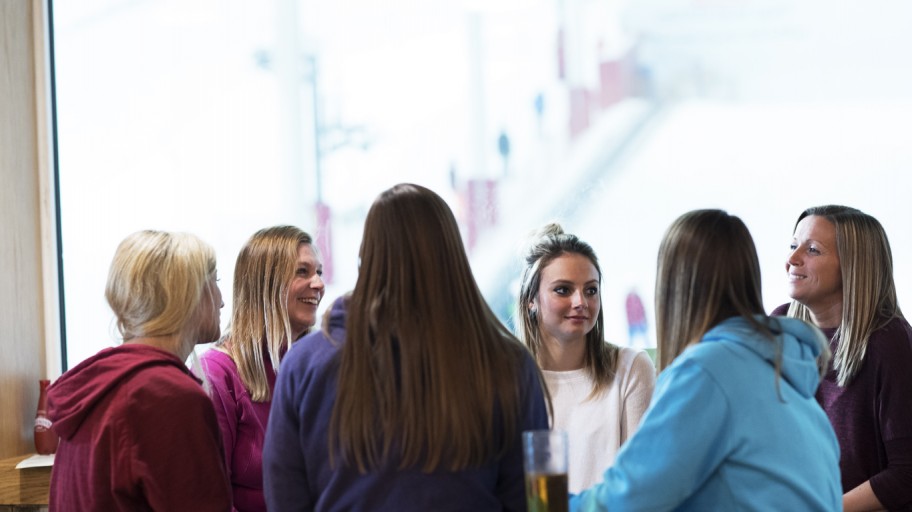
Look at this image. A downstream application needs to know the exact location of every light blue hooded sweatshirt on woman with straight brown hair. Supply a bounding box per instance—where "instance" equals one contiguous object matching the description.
[570,316,842,512]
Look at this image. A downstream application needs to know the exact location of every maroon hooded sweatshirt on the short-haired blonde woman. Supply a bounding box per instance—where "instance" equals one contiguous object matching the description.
[48,344,231,511]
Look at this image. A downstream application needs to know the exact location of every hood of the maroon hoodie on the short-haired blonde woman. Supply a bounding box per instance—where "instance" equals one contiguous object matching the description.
[48,344,201,439]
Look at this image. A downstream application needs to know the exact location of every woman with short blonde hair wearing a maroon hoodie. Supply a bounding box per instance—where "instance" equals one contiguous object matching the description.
[48,231,231,511]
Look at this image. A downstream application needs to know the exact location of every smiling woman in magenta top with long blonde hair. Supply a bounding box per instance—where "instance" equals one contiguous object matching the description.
[201,226,324,512]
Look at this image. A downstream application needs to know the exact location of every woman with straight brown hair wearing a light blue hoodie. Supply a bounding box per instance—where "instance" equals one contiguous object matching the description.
[570,210,842,511]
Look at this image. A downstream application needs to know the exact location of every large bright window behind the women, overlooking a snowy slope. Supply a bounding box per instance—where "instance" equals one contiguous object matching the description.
[52,0,912,366]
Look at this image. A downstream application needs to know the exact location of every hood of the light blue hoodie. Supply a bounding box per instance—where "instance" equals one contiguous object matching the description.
[701,316,827,397]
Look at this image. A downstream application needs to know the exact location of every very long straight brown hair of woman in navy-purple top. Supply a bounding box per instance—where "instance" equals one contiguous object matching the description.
[330,184,541,472]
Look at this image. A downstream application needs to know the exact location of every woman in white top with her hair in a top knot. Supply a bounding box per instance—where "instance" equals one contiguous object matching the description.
[517,223,656,493]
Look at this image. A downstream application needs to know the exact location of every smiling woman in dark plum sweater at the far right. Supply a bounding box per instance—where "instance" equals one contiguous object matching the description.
[773,205,912,512]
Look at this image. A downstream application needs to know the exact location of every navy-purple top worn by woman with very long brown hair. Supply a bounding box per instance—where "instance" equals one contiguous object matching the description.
[263,300,548,512]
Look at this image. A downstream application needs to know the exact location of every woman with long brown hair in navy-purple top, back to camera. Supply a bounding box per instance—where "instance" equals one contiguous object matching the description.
[263,184,548,511]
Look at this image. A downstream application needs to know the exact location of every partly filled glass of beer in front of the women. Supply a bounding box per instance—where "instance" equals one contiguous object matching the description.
[523,430,570,512]
